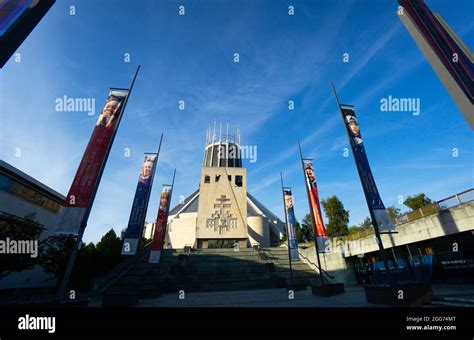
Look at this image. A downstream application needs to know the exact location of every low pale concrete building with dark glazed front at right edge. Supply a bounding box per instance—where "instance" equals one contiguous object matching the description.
[300,189,474,285]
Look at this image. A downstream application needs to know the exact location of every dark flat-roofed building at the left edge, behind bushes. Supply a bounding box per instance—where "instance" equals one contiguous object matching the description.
[0,160,64,289]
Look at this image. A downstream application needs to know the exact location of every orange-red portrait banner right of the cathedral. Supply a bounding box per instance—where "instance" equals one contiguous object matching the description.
[303,161,329,253]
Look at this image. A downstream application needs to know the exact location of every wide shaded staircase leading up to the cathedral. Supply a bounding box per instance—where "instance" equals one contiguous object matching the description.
[100,247,319,304]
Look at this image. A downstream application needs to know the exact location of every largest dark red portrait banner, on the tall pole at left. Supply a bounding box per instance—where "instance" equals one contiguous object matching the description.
[56,90,129,236]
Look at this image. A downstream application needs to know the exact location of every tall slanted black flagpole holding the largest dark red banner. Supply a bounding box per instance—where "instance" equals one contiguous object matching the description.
[56,65,140,305]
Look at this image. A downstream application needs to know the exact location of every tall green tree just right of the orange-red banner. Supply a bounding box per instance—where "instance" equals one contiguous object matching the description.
[321,195,349,237]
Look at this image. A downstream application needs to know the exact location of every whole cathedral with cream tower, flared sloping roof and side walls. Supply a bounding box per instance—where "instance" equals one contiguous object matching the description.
[144,124,285,249]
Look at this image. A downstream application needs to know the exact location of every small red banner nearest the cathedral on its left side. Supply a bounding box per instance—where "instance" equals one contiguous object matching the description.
[148,185,173,263]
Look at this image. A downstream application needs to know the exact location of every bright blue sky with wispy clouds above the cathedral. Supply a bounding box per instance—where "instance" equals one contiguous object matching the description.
[0,0,474,242]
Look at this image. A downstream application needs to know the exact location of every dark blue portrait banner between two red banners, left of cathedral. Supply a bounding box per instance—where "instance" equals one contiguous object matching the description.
[122,154,158,255]
